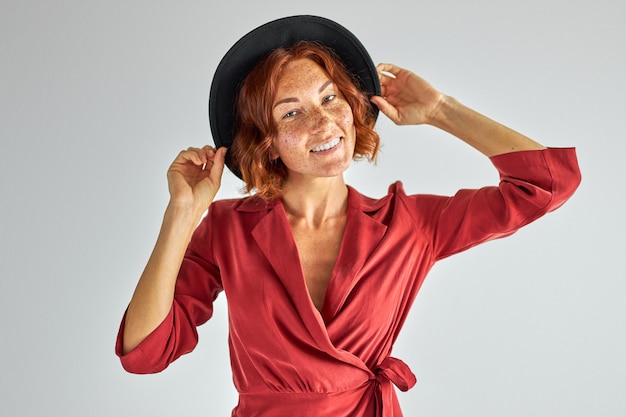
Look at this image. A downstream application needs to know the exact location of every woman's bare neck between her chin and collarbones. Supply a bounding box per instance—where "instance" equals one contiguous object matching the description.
[282,175,348,227]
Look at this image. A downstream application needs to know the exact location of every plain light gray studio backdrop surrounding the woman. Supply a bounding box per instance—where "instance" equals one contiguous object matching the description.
[0,0,626,417]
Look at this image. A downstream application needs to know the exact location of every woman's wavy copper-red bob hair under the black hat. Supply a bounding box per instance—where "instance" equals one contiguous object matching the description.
[230,41,380,200]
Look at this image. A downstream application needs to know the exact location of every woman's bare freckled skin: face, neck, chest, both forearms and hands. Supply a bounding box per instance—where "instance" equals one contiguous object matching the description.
[123,60,544,353]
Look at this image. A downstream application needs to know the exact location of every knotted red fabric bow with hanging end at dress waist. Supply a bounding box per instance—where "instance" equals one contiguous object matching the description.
[374,356,417,417]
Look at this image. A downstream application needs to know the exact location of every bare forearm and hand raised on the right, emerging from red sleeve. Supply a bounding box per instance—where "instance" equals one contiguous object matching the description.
[371,64,545,157]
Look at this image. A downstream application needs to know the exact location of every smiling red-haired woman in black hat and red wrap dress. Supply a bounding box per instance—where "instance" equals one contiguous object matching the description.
[117,16,580,417]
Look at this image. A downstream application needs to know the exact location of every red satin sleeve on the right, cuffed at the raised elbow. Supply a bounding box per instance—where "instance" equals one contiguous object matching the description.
[408,148,581,259]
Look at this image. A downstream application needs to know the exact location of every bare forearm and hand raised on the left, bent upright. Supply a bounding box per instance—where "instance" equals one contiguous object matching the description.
[122,146,226,354]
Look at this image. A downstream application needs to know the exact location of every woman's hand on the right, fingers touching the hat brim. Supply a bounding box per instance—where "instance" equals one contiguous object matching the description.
[371,64,445,125]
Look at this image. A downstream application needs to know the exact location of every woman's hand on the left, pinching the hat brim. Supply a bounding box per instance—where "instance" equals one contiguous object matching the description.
[167,145,226,211]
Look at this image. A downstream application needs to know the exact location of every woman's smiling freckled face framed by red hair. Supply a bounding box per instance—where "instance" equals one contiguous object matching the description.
[271,59,356,181]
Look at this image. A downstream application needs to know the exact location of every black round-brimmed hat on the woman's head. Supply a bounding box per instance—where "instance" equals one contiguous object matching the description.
[209,15,380,178]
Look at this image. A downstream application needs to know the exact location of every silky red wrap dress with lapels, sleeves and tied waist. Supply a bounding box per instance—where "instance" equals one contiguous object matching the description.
[116,148,580,417]
